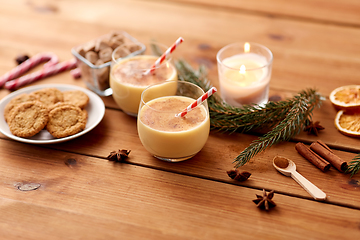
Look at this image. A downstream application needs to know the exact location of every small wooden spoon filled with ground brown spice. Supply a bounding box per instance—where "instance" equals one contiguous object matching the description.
[273,156,326,200]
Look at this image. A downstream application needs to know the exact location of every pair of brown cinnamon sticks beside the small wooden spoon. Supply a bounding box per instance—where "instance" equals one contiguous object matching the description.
[295,140,347,172]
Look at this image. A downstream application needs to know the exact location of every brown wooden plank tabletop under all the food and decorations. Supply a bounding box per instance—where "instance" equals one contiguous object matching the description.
[0,0,360,239]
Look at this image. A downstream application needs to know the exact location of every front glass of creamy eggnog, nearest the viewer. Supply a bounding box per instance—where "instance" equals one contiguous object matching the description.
[137,81,210,162]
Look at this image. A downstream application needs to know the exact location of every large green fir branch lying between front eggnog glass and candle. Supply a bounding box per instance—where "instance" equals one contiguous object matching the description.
[176,60,321,168]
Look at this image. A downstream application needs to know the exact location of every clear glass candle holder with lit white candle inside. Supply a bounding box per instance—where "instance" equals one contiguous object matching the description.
[216,42,273,107]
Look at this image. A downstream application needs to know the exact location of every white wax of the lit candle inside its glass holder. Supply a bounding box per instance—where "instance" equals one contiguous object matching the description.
[219,53,271,107]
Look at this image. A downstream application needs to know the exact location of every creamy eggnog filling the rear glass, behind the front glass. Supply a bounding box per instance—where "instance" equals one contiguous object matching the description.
[110,55,177,116]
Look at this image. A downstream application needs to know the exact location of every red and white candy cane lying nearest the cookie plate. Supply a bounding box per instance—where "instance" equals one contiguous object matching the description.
[4,58,76,90]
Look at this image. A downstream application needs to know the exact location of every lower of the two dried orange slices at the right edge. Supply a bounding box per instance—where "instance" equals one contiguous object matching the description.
[335,110,360,137]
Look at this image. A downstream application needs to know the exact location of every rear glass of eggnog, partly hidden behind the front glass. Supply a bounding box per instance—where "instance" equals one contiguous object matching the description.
[110,42,177,116]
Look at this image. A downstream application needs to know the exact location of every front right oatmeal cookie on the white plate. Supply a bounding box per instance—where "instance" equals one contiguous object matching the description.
[46,106,87,138]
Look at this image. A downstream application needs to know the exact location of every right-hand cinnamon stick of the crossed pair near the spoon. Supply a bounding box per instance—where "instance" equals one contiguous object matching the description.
[310,140,347,172]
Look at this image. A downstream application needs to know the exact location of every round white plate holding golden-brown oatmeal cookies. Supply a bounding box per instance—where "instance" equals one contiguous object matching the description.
[0,84,105,144]
